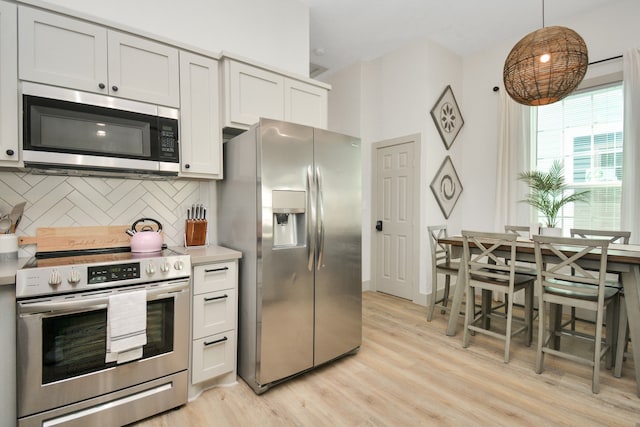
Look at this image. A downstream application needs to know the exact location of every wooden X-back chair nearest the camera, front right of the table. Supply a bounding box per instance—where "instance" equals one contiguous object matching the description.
[533,236,619,393]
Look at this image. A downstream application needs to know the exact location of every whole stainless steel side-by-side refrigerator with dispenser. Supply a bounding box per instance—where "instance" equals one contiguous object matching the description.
[216,119,362,393]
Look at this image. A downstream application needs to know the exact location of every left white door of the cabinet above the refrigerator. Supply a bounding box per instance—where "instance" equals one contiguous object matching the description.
[225,61,284,129]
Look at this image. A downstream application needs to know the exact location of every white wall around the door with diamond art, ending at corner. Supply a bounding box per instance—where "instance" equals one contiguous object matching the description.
[329,41,466,300]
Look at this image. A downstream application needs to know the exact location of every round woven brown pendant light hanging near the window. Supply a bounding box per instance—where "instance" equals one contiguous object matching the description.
[503,2,589,106]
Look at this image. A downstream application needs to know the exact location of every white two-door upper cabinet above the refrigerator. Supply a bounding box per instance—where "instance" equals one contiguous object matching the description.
[223,58,328,129]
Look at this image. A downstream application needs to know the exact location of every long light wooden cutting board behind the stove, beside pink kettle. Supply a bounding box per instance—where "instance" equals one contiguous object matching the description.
[18,225,131,252]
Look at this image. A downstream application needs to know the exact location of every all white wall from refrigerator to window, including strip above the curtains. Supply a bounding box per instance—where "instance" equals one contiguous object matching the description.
[327,0,640,301]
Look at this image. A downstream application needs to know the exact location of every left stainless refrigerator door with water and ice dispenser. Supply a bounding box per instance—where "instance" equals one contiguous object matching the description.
[256,119,315,384]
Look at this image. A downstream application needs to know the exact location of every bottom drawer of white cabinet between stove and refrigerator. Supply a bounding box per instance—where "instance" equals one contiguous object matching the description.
[191,331,236,384]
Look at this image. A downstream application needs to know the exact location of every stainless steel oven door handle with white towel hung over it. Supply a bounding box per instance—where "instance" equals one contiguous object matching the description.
[18,280,189,315]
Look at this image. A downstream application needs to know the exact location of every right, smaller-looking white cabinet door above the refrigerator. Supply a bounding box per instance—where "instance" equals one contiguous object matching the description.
[284,78,328,129]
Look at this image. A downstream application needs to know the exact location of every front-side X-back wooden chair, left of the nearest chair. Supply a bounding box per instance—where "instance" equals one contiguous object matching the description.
[462,230,535,363]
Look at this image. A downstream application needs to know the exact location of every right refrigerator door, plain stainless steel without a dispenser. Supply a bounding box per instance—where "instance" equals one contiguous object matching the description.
[314,129,362,365]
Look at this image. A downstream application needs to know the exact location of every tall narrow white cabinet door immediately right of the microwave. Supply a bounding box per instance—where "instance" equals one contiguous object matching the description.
[180,52,222,179]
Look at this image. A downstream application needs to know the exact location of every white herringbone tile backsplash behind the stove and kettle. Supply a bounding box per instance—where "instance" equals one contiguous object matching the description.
[0,172,216,257]
